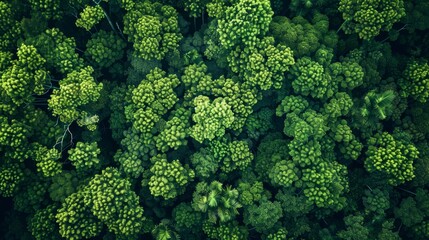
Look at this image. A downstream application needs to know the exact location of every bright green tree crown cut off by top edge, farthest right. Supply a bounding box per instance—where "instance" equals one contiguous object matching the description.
[338,0,405,40]
